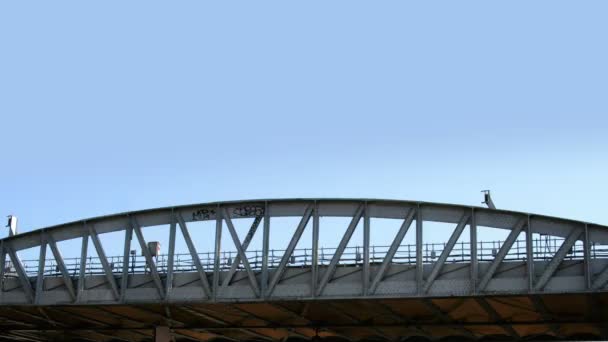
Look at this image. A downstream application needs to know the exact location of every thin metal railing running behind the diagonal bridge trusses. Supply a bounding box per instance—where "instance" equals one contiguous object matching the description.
[5,238,608,277]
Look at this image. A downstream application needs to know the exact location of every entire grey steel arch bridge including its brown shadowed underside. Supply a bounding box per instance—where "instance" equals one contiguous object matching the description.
[0,199,608,341]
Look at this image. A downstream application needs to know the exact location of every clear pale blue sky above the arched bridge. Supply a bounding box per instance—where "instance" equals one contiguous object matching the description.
[0,0,608,260]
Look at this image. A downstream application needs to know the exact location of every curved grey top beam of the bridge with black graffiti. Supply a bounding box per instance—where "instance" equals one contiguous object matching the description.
[2,199,608,251]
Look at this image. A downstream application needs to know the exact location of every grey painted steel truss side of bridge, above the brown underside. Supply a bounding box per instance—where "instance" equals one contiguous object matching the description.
[0,199,608,306]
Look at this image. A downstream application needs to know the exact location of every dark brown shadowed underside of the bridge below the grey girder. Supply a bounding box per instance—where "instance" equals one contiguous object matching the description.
[0,293,608,341]
